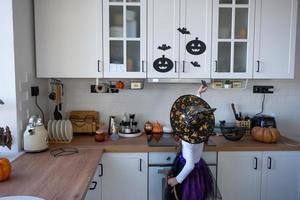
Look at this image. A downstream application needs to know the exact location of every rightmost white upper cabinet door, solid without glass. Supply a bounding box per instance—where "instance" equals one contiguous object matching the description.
[253,0,298,79]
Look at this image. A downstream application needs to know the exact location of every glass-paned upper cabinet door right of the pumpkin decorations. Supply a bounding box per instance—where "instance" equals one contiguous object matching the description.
[212,0,255,78]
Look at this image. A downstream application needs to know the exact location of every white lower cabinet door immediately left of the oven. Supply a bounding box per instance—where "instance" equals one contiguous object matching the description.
[102,153,148,200]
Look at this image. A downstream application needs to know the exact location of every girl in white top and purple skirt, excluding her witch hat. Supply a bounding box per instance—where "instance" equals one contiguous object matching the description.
[168,85,221,200]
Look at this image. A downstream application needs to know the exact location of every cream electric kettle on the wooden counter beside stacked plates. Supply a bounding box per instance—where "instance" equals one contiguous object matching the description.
[24,115,48,152]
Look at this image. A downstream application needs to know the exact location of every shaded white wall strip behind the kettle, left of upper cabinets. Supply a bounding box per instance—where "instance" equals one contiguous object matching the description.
[13,0,48,149]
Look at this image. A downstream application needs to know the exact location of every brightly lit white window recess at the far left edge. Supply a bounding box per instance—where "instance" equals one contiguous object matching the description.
[0,0,17,152]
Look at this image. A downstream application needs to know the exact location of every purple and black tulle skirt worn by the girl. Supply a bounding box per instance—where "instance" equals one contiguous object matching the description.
[166,153,222,200]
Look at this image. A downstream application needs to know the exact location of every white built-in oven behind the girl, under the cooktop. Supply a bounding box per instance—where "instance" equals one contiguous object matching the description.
[148,152,217,200]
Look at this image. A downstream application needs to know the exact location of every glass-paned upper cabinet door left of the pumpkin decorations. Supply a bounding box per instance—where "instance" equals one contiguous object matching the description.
[103,0,146,78]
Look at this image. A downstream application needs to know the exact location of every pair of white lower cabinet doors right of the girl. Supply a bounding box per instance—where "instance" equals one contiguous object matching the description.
[218,151,300,200]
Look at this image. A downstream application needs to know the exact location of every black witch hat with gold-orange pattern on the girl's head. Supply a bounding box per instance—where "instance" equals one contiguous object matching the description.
[170,95,215,144]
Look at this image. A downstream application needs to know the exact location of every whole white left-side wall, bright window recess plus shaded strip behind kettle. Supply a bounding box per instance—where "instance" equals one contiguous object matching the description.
[0,0,48,153]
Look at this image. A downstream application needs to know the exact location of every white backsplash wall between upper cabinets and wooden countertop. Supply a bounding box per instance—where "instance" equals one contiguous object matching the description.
[59,1,300,141]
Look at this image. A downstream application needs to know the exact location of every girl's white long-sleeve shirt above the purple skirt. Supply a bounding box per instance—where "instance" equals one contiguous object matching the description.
[176,140,204,183]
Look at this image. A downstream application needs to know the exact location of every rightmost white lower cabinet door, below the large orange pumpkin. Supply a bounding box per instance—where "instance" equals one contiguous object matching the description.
[261,152,300,200]
